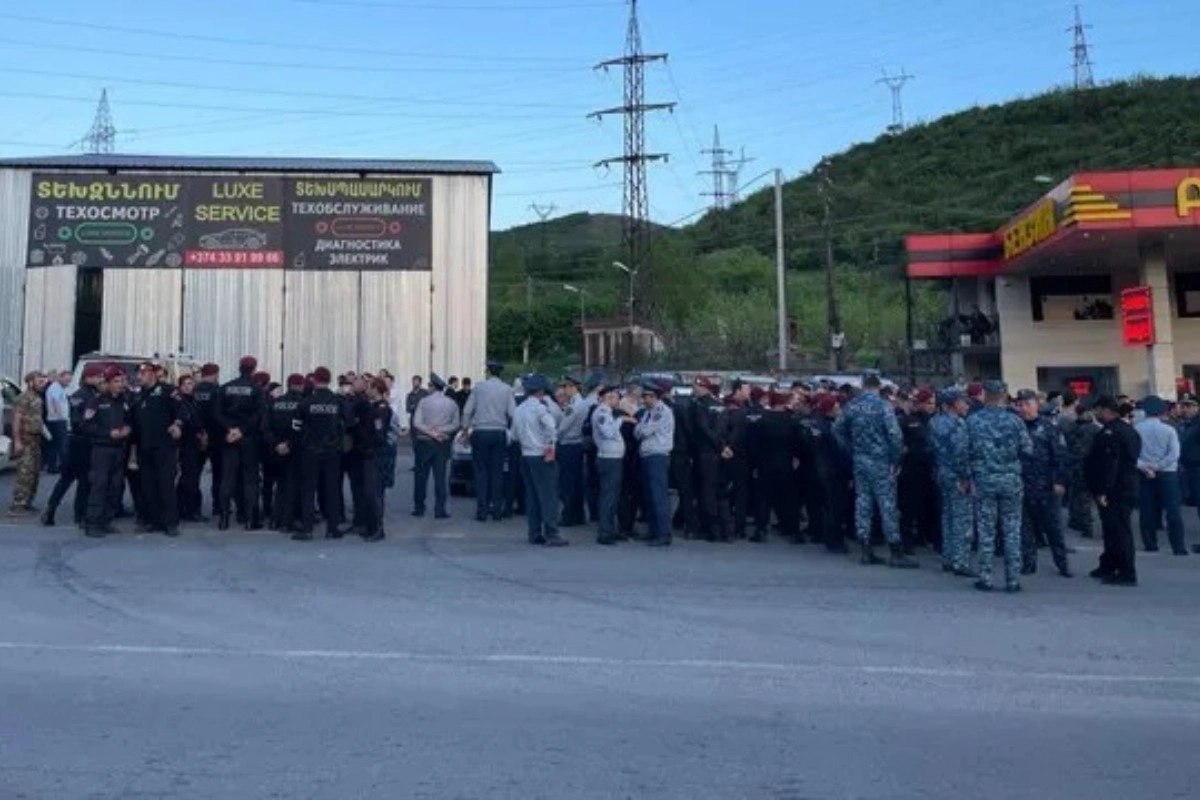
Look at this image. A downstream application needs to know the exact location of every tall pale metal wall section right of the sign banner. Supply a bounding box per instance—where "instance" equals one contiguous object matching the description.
[432,175,488,378]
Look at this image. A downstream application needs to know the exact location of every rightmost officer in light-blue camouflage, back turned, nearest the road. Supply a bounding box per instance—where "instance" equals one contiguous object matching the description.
[966,380,1033,591]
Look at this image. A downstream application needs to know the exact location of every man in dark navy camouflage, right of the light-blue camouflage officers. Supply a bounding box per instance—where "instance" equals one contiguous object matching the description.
[1016,389,1072,578]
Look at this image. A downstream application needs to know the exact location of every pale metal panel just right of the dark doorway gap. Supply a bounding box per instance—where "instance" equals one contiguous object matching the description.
[100,269,184,355]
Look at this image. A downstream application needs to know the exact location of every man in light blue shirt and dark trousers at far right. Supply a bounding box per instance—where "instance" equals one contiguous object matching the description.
[1136,396,1188,555]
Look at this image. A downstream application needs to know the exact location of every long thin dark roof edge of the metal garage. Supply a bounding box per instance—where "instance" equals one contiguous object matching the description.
[0,154,500,175]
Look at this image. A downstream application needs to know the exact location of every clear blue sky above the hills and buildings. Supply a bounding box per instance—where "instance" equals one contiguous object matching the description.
[0,0,1200,229]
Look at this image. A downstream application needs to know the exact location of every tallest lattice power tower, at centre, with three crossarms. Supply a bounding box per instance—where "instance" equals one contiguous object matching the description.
[588,0,676,275]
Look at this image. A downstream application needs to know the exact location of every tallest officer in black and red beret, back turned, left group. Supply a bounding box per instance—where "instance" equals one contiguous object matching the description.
[214,355,266,530]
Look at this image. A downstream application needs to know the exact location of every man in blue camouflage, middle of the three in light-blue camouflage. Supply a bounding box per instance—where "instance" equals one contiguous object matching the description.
[929,389,978,578]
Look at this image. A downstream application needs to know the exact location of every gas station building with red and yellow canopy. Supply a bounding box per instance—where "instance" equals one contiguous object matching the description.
[906,167,1200,398]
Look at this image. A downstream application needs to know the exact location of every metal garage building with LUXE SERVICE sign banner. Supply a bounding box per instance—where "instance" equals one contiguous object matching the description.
[0,155,499,377]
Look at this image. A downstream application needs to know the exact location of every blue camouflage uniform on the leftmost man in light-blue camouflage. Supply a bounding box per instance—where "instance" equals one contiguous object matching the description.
[833,391,904,545]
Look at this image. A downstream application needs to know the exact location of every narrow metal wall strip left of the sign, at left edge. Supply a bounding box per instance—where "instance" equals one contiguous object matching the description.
[0,169,31,378]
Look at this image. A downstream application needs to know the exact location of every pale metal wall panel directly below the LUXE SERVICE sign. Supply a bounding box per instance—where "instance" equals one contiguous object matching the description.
[184,270,283,379]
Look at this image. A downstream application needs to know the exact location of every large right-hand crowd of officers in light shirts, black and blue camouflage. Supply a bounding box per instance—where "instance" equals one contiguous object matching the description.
[513,374,1140,591]
